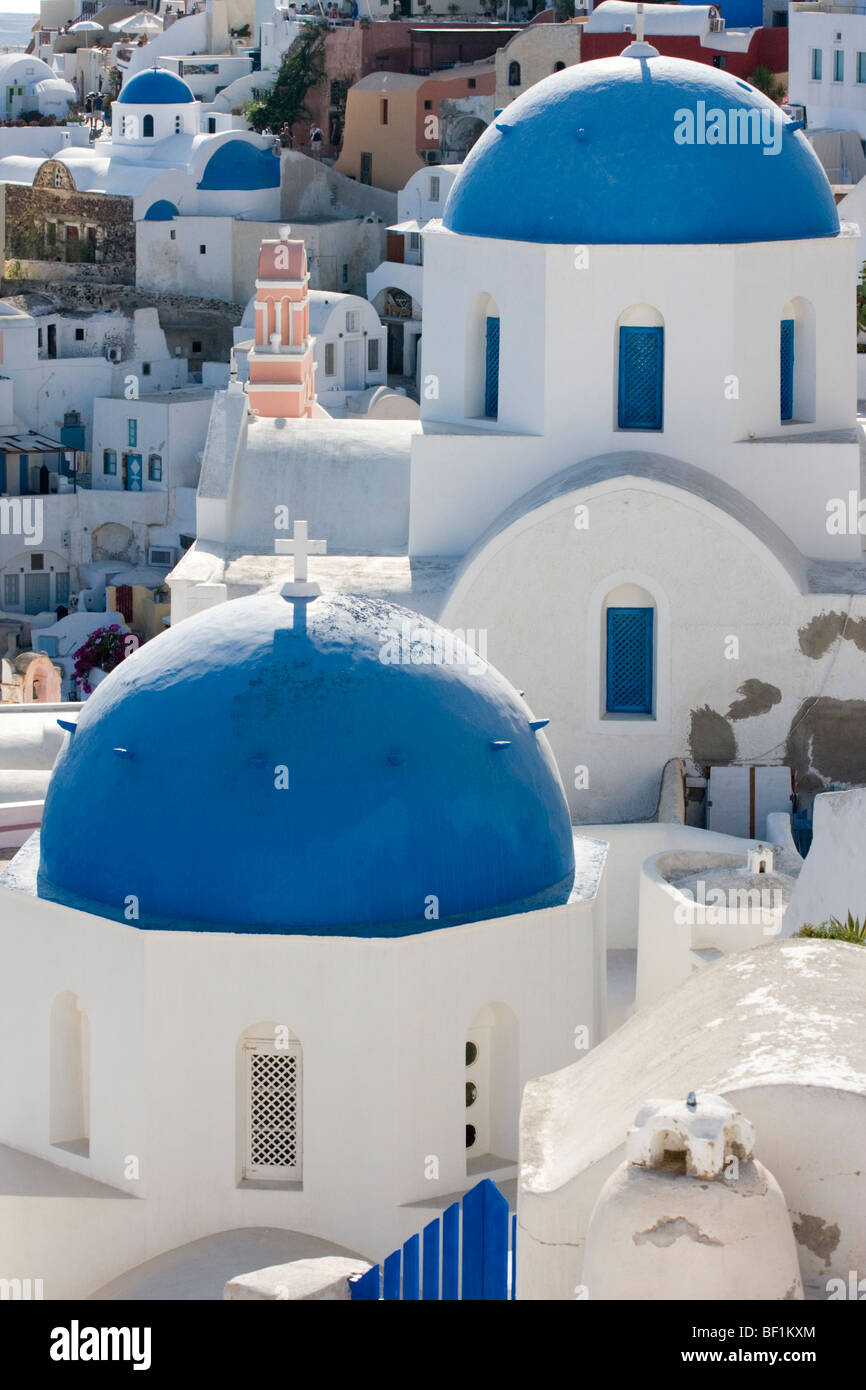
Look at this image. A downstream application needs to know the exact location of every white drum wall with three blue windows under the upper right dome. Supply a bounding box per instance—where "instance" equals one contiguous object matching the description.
[411,229,860,559]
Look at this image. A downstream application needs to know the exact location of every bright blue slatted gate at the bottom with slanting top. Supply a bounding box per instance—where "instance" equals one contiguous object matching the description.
[349,1177,517,1302]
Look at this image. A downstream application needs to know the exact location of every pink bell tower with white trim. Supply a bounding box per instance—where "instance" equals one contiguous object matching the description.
[247,228,316,420]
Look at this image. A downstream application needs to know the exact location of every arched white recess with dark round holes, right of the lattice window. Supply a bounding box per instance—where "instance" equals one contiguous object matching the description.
[464,1004,520,1172]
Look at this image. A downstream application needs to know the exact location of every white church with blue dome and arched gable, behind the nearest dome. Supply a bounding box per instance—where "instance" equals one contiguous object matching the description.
[171,44,866,824]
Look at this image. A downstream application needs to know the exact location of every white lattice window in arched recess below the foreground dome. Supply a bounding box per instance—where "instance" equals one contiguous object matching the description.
[243,1040,302,1183]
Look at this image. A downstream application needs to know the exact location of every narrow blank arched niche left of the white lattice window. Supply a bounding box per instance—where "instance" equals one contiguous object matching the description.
[49,990,90,1158]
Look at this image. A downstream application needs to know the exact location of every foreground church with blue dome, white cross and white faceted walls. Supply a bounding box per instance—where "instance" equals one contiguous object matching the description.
[0,550,605,1297]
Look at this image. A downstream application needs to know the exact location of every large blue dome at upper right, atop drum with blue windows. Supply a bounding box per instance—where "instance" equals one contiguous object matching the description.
[443,44,840,245]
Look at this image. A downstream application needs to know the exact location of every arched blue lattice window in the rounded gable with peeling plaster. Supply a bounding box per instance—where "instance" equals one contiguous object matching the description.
[602,584,657,719]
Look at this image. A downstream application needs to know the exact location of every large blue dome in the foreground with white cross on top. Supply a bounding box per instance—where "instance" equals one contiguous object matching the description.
[39,595,574,937]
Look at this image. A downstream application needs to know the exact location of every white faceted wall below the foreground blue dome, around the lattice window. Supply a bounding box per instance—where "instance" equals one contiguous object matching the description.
[0,890,603,1298]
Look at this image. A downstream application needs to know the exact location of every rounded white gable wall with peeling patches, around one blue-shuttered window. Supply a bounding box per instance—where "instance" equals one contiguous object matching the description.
[439,478,866,822]
